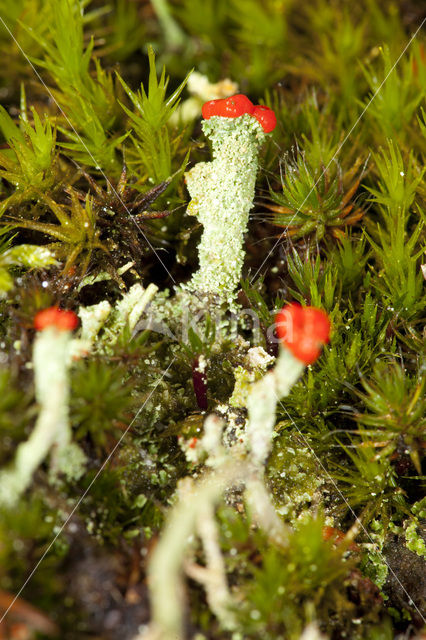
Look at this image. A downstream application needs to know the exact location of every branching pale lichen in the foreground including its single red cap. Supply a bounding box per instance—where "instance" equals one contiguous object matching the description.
[138,308,329,640]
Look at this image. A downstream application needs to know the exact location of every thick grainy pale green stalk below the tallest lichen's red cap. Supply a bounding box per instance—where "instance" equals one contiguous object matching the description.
[185,114,266,306]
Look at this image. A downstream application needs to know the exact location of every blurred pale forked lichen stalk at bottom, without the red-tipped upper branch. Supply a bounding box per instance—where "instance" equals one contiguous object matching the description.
[140,428,289,640]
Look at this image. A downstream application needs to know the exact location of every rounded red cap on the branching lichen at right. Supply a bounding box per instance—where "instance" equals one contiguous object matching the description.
[275,302,331,364]
